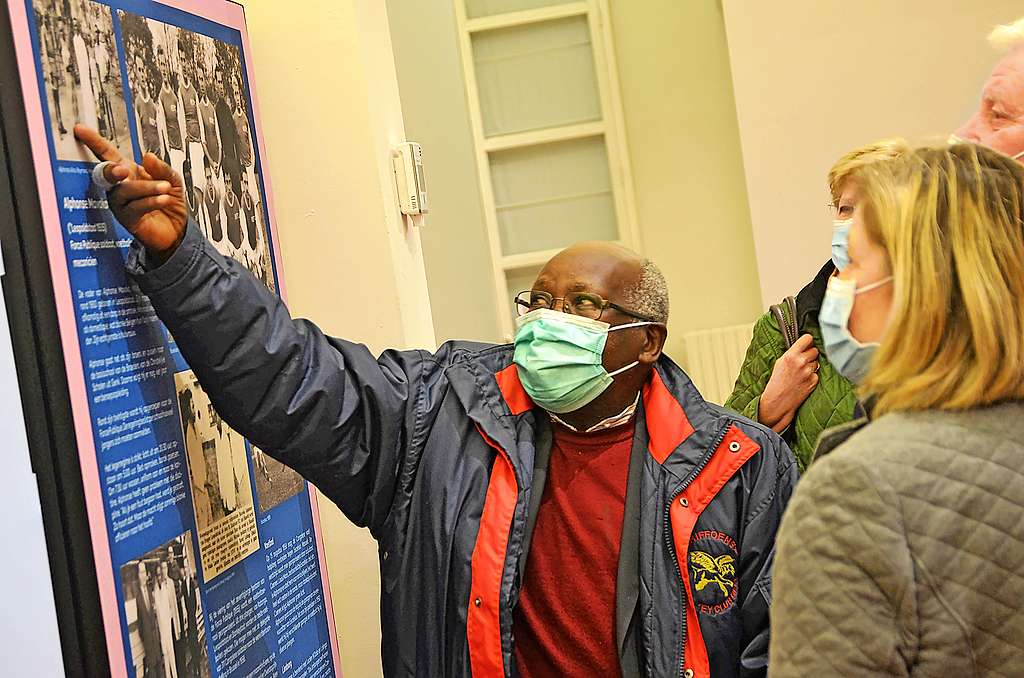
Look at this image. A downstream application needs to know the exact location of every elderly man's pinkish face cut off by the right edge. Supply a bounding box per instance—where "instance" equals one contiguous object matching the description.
[955,46,1024,156]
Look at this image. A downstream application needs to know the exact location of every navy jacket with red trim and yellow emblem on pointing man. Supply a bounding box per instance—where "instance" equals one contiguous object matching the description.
[128,224,797,678]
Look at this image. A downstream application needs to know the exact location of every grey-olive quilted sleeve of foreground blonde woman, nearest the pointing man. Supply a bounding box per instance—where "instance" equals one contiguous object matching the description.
[769,450,916,677]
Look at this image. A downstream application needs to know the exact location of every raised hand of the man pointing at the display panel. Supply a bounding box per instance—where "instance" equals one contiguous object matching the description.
[75,125,188,263]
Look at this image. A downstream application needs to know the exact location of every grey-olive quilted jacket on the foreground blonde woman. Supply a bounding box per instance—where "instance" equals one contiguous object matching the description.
[769,402,1024,678]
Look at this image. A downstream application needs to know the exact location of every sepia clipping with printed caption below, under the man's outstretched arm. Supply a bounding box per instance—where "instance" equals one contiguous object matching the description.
[174,372,253,533]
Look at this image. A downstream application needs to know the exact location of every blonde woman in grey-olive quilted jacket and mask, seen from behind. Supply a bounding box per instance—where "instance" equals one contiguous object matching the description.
[769,144,1024,676]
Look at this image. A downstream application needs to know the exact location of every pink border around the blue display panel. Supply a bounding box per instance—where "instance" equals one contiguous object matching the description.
[7,0,342,678]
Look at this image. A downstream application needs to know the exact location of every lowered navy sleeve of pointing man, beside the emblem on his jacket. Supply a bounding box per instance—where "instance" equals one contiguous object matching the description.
[737,431,799,678]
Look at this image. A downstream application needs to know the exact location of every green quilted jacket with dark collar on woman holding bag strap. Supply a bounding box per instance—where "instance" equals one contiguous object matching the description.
[725,260,858,472]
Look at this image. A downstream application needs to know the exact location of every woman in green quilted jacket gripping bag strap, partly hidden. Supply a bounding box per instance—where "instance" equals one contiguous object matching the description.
[725,139,908,472]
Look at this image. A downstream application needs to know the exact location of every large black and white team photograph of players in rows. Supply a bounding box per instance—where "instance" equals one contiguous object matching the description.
[119,11,276,290]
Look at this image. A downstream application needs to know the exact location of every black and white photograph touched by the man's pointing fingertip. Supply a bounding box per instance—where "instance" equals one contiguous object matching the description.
[32,0,131,162]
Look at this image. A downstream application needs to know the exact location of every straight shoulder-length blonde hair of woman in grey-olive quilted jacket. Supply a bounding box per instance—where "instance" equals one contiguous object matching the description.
[857,143,1024,415]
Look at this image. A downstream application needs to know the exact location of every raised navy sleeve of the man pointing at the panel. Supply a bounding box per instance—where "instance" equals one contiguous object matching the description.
[128,223,433,535]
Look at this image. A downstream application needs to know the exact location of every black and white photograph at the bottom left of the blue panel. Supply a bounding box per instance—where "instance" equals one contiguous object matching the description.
[121,531,210,678]
